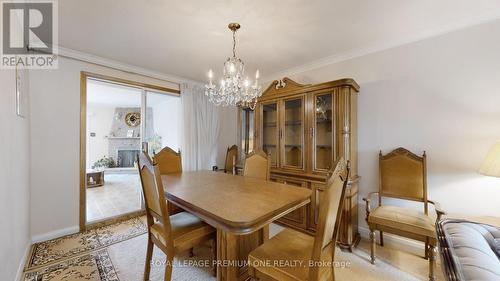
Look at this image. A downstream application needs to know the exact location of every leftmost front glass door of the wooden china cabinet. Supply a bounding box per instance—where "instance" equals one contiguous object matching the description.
[262,102,279,167]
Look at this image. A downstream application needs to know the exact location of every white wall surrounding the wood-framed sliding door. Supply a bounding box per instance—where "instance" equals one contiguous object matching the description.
[30,58,236,240]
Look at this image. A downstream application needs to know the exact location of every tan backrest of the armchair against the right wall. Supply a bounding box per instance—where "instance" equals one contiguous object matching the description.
[379,147,427,206]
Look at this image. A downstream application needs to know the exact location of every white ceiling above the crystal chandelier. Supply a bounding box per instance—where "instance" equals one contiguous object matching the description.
[59,0,500,81]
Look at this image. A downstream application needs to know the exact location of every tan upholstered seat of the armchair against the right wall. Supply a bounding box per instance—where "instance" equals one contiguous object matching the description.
[368,206,436,237]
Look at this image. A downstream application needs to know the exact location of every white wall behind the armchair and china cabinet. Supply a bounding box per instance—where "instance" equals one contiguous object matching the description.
[274,21,500,225]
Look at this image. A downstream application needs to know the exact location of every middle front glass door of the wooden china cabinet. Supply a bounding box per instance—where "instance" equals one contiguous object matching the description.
[281,98,304,169]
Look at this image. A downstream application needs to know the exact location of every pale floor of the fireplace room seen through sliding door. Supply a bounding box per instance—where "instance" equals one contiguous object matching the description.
[87,172,142,222]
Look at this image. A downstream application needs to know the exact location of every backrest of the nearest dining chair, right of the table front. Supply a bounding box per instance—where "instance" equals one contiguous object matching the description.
[309,158,349,280]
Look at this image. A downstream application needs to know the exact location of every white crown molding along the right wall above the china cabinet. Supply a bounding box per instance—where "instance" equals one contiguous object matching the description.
[261,14,500,83]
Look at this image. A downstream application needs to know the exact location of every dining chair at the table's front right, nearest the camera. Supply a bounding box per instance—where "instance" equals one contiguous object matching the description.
[248,159,349,281]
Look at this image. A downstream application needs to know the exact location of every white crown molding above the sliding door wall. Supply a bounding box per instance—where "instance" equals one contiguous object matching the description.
[57,46,202,85]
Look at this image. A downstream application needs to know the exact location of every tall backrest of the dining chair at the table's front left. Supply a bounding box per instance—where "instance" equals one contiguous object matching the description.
[137,152,173,249]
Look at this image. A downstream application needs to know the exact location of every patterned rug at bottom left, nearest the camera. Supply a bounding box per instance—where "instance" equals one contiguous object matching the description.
[23,249,119,281]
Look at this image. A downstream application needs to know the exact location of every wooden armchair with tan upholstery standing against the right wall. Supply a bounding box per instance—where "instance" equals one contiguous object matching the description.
[363,147,444,280]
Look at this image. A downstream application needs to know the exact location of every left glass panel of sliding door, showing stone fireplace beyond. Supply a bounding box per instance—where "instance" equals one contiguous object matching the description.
[86,79,143,223]
